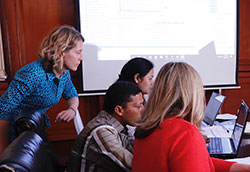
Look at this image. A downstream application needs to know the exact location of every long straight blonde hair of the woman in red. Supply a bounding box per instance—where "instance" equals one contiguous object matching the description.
[135,62,205,138]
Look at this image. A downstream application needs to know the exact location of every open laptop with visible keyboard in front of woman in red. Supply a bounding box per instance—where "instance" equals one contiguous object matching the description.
[207,100,249,159]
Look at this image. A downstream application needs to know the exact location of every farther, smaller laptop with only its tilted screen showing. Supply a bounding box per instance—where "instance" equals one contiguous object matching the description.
[202,92,226,126]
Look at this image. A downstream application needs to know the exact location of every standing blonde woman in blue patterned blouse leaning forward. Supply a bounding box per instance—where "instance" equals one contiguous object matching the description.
[0,26,84,153]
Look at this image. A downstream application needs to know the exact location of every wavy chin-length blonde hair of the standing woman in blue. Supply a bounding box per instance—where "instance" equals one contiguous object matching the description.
[39,26,84,74]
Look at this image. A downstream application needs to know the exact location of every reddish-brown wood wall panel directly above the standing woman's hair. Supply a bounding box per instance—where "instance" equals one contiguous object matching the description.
[17,0,76,63]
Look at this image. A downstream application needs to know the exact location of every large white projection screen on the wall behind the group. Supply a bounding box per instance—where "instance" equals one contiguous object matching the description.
[78,0,238,93]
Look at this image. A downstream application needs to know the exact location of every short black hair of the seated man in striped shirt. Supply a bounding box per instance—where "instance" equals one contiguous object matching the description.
[103,81,142,114]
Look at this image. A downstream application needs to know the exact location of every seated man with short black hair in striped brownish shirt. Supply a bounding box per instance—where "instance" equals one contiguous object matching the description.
[68,81,143,172]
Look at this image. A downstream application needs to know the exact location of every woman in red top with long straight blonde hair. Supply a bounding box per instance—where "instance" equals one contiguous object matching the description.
[132,62,250,172]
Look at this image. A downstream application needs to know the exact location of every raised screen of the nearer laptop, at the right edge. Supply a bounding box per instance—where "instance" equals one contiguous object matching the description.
[232,100,249,150]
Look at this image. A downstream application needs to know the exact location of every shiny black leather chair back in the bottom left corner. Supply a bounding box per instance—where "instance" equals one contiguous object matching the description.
[0,131,63,172]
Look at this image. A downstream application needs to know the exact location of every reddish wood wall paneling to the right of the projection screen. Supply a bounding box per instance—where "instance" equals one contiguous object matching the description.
[222,0,250,120]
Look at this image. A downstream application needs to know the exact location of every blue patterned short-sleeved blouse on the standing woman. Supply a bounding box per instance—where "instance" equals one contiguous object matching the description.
[0,59,77,140]
